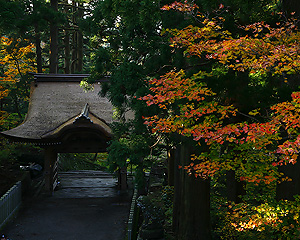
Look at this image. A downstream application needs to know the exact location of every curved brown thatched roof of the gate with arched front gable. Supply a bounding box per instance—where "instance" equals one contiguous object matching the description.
[1,74,113,143]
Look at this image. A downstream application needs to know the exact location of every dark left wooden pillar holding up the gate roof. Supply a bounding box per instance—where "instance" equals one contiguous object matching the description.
[44,147,58,195]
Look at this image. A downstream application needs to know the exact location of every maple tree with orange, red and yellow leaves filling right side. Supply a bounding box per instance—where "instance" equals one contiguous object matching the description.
[139,1,300,237]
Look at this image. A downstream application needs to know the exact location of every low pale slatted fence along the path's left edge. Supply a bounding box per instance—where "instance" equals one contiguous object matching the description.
[0,181,22,229]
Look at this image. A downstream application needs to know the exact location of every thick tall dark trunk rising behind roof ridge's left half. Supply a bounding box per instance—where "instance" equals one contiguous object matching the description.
[49,0,58,73]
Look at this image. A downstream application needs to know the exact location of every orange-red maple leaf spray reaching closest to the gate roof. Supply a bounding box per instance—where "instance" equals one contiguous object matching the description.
[140,70,235,140]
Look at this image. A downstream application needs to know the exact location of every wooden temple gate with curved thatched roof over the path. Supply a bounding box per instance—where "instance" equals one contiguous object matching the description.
[1,74,127,193]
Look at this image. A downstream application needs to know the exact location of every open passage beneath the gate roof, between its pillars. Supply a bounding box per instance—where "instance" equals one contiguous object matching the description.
[53,153,119,199]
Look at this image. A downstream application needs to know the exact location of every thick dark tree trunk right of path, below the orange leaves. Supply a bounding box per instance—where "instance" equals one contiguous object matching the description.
[173,144,211,240]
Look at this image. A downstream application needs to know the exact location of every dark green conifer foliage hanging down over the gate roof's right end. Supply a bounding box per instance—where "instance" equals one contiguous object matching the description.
[84,0,183,187]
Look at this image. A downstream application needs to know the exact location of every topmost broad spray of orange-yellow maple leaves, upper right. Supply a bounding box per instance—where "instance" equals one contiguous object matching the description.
[165,11,300,74]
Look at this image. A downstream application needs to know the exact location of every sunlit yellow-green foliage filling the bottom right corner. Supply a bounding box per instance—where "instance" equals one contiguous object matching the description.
[211,173,300,240]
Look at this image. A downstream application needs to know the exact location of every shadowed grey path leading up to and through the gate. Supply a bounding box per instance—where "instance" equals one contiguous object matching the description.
[2,171,131,240]
